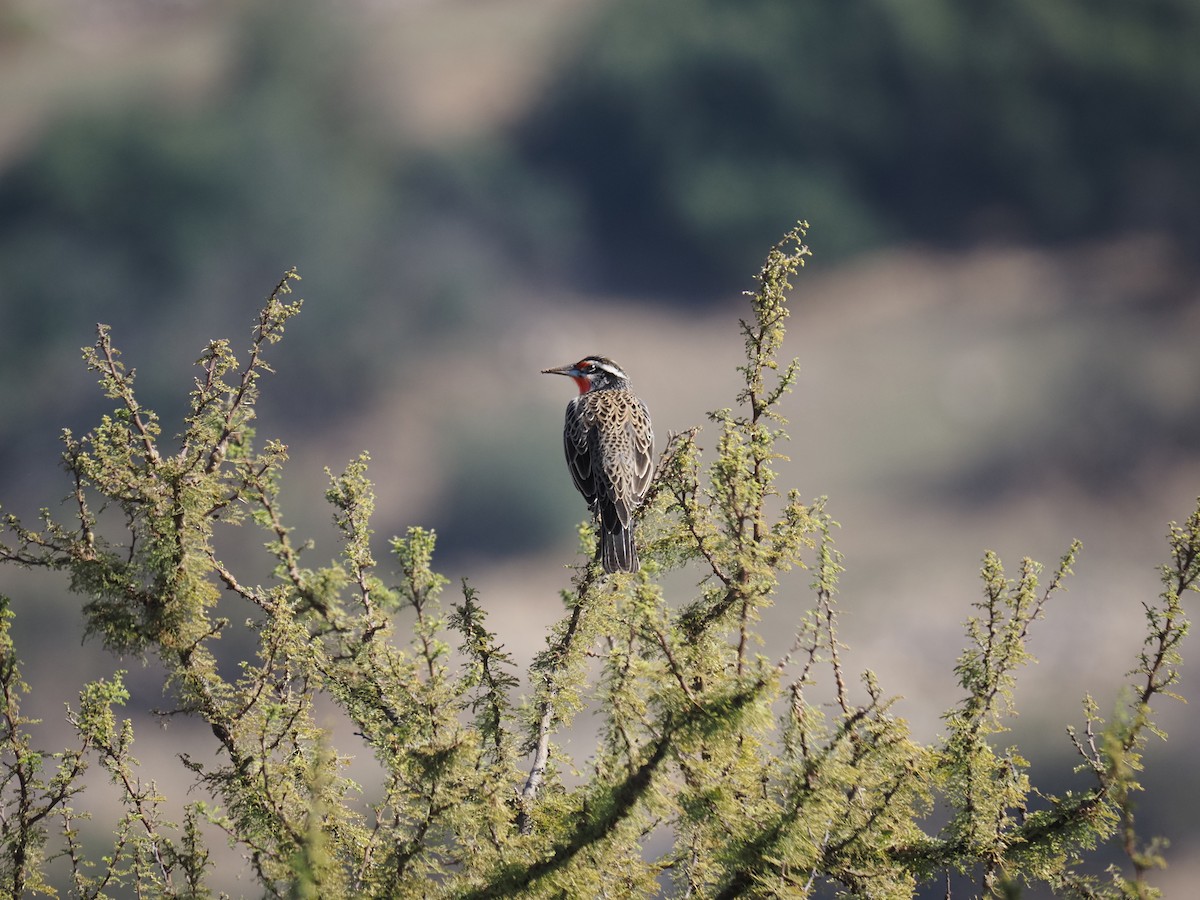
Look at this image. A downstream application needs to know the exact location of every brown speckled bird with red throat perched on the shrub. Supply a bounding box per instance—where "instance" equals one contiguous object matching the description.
[541,356,654,572]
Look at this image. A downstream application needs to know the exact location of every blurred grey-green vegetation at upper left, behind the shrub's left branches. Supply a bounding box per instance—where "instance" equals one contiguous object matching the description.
[0,2,520,513]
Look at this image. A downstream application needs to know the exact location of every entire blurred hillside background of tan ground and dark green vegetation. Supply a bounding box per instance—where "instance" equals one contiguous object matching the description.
[0,0,1200,896]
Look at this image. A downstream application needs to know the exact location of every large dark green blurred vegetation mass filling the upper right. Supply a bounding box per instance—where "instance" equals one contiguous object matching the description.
[517,0,1200,295]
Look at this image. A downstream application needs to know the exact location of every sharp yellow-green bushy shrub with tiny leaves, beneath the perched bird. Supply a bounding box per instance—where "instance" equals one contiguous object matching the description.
[0,229,1200,898]
